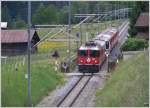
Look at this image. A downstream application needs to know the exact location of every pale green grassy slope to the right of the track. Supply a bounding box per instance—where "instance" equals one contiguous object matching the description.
[96,52,149,107]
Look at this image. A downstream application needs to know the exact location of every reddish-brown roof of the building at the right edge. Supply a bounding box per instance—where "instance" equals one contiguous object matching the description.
[135,13,149,27]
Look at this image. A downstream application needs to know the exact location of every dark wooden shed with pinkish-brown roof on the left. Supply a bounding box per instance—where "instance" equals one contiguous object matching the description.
[1,30,40,56]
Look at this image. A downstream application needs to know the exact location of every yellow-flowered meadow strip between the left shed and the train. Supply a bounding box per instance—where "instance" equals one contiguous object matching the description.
[36,42,77,60]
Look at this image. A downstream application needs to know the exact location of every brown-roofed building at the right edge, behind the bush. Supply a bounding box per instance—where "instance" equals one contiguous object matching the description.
[135,13,149,40]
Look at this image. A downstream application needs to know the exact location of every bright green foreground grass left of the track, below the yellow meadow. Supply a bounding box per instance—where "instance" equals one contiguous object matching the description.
[1,58,64,106]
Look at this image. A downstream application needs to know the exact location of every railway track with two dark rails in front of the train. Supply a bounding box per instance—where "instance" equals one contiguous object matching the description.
[56,75,93,107]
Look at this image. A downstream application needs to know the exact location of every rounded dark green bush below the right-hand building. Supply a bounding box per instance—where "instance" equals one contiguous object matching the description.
[122,38,148,51]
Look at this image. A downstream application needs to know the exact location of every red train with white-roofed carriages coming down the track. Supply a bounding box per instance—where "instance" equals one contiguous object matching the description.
[77,28,118,73]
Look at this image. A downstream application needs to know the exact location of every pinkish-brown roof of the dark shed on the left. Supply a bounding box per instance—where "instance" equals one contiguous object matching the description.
[1,30,35,43]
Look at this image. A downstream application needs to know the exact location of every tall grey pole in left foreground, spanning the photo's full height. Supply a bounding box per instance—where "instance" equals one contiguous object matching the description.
[27,1,32,107]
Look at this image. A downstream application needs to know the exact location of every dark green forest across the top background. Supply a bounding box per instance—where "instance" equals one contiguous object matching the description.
[1,1,148,28]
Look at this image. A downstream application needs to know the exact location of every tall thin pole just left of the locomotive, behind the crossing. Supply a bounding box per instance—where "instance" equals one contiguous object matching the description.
[68,1,71,72]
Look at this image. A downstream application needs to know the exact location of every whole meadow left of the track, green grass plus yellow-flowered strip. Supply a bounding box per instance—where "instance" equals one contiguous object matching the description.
[1,42,76,106]
